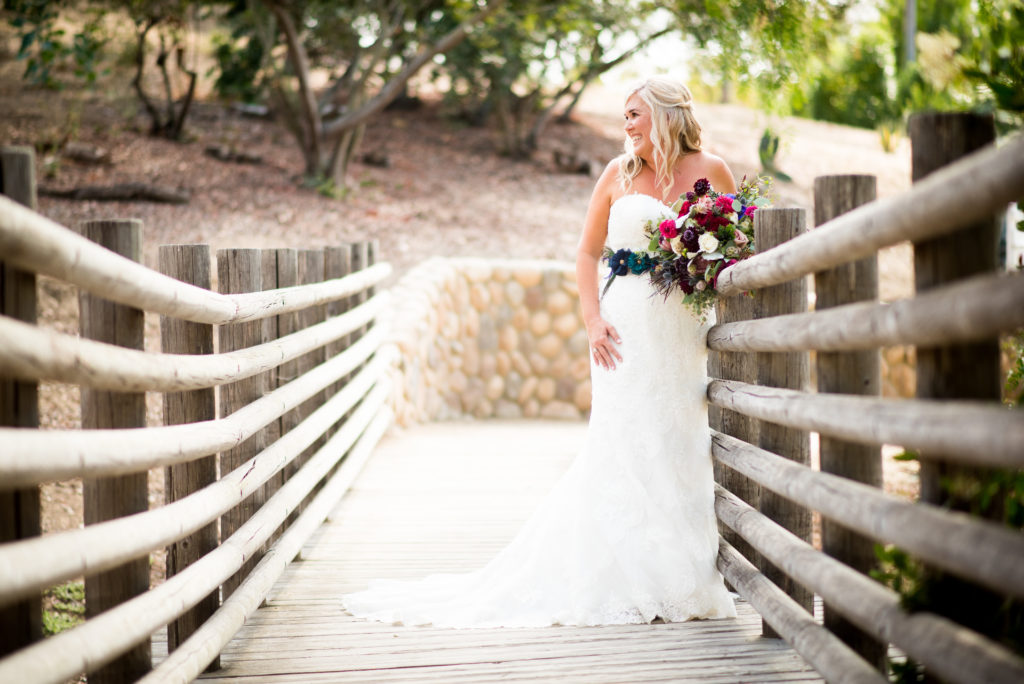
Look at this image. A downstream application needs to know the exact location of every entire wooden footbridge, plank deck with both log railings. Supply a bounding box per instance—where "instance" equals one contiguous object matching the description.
[0,115,1024,683]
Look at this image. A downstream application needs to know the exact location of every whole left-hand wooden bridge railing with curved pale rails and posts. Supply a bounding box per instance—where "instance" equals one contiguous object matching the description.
[0,148,394,682]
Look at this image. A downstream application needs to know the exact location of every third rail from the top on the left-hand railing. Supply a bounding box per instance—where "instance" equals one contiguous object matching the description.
[0,325,387,489]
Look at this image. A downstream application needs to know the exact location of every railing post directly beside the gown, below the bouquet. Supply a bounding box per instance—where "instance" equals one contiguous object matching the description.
[708,295,761,565]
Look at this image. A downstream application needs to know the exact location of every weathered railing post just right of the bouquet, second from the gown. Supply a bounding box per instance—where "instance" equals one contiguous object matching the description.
[754,209,814,637]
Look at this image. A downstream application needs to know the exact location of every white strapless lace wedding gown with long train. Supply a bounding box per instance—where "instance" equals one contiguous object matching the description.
[343,195,735,628]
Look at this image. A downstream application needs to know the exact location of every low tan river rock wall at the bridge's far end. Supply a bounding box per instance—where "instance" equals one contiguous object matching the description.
[391,258,591,426]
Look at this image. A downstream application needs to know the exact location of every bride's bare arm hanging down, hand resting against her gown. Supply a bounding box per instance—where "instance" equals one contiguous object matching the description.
[577,160,623,368]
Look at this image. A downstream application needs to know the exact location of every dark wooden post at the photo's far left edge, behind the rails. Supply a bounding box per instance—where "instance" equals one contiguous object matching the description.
[0,146,43,655]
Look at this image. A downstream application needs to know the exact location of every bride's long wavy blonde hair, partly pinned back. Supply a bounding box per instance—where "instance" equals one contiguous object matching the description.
[618,78,700,199]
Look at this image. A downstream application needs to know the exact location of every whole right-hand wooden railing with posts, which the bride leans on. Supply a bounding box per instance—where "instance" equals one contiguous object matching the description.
[708,115,1024,683]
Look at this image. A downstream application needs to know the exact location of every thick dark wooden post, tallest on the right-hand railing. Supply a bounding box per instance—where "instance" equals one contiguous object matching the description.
[908,113,1004,663]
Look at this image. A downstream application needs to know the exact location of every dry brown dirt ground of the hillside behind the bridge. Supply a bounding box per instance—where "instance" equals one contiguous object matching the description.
[0,42,916,581]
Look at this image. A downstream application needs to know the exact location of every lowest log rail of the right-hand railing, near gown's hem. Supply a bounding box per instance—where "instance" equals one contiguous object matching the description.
[718,540,888,684]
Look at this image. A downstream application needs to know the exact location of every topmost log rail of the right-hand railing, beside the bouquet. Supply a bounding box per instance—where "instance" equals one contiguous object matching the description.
[716,135,1024,296]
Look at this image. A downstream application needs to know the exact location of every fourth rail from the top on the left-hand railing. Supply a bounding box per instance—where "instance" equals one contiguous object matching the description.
[0,359,390,606]
